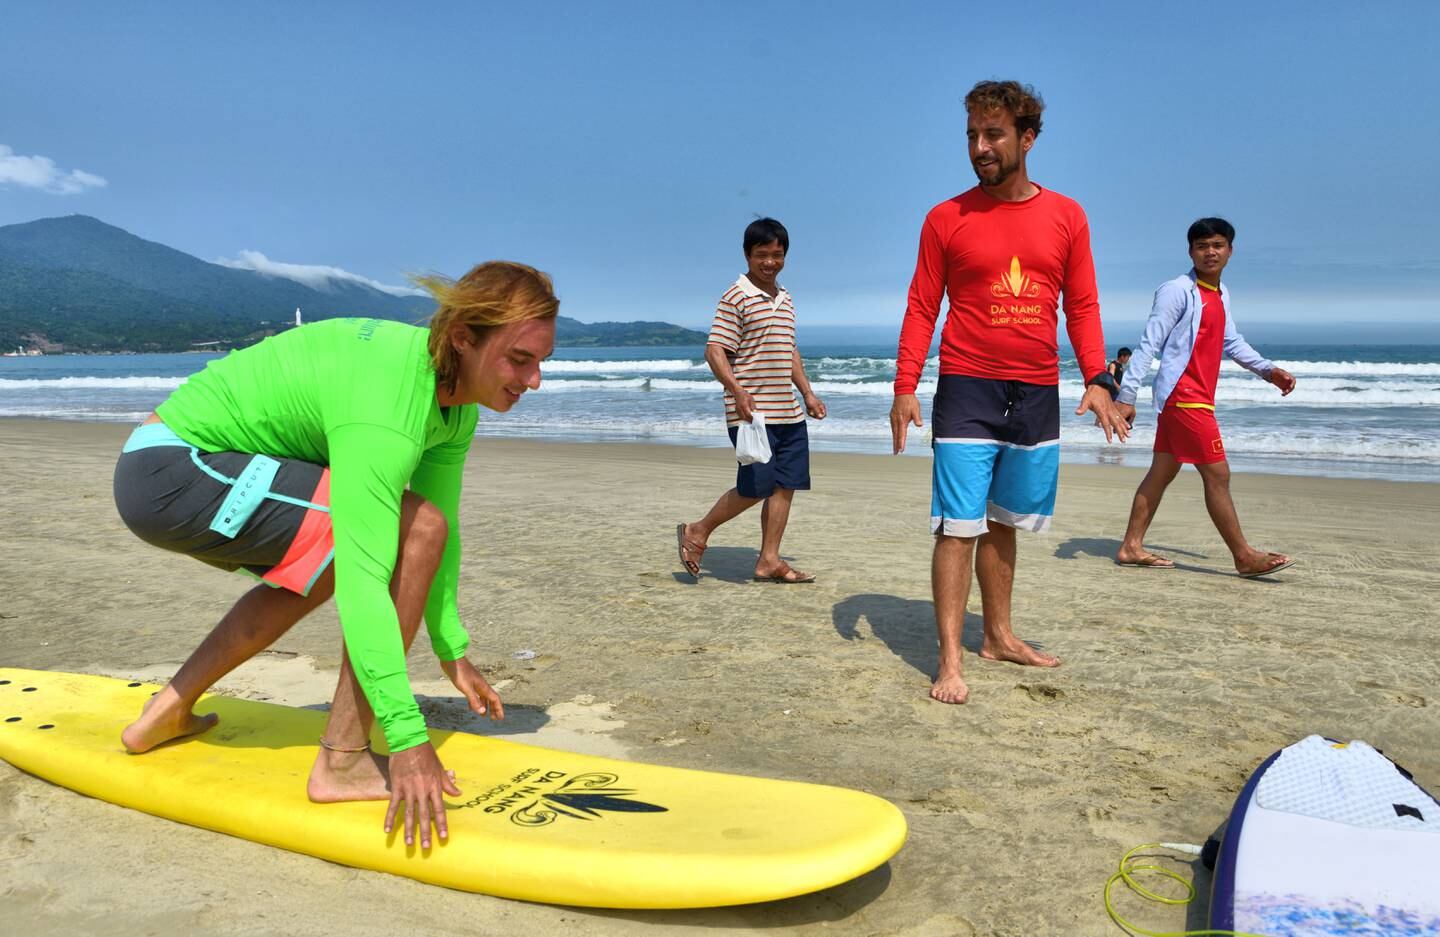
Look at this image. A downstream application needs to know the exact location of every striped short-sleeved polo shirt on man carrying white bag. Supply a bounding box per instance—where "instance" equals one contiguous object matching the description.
[707,273,805,426]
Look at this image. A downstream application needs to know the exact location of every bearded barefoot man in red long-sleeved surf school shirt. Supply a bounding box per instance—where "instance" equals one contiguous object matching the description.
[890,81,1128,702]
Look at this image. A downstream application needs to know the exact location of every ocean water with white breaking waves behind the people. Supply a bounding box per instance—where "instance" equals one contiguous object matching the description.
[0,343,1440,482]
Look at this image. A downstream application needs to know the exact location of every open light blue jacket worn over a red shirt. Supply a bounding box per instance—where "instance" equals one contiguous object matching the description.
[1116,268,1274,413]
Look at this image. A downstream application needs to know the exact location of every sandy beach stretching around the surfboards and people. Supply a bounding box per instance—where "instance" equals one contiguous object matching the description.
[0,420,1440,937]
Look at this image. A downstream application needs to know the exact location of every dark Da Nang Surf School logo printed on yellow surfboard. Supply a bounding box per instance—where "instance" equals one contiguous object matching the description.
[458,767,668,826]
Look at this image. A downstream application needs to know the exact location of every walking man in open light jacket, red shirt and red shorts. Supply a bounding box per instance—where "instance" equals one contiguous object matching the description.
[1115,217,1295,579]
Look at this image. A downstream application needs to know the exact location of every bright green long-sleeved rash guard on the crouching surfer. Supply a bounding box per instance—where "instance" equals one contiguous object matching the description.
[156,320,478,751]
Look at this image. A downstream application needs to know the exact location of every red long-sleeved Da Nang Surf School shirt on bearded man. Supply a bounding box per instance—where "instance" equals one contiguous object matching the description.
[894,187,1104,394]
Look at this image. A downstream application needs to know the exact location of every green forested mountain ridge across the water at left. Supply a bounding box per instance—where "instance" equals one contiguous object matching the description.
[0,214,706,351]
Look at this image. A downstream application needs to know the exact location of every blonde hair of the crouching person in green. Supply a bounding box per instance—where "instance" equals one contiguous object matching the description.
[410,261,560,389]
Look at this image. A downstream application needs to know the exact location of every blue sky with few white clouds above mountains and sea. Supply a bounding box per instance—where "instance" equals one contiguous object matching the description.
[0,0,1440,333]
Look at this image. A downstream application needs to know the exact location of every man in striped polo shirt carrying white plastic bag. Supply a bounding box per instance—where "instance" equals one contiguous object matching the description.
[675,217,825,584]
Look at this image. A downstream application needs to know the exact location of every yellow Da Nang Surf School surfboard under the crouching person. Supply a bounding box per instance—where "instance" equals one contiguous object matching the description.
[0,668,906,908]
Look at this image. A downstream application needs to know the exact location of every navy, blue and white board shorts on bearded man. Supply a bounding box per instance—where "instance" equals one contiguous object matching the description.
[930,374,1060,537]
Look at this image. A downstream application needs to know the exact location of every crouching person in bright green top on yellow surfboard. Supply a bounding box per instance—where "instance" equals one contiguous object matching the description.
[115,261,559,848]
